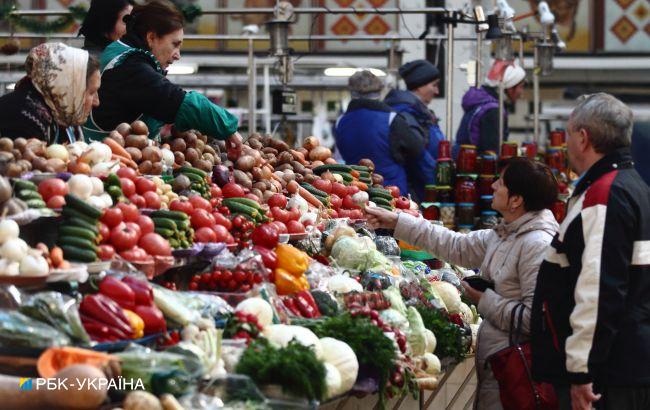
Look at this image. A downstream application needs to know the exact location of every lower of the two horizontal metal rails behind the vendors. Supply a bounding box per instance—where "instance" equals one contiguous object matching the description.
[0,32,476,41]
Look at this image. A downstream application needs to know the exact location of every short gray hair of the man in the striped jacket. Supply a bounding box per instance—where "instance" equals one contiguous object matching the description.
[569,93,634,154]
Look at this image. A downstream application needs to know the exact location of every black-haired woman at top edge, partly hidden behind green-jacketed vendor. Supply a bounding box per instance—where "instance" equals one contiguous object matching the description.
[79,0,135,57]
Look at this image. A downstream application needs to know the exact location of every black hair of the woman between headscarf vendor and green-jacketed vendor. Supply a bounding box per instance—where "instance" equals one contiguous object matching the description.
[79,0,135,47]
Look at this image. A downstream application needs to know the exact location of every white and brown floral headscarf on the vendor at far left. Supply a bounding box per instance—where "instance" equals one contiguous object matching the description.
[25,43,88,127]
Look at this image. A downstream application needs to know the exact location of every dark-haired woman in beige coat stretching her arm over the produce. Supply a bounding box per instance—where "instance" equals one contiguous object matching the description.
[366,158,558,410]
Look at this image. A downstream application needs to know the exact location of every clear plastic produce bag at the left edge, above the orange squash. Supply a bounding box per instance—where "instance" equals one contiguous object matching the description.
[0,309,71,349]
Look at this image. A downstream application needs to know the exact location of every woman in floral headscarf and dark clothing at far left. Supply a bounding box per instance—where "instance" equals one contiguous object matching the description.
[0,43,100,143]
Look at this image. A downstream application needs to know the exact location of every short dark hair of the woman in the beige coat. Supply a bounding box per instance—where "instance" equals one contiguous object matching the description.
[503,157,558,211]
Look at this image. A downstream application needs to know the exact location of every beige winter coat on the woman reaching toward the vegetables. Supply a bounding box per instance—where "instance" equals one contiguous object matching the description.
[395,210,558,410]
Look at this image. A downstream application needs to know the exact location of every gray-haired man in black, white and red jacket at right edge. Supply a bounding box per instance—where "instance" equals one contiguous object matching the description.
[531,93,650,410]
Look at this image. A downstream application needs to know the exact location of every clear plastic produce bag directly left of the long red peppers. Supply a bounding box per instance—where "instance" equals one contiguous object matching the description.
[20,292,90,343]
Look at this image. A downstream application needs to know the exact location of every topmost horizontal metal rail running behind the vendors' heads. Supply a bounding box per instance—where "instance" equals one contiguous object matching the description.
[11,7,453,16]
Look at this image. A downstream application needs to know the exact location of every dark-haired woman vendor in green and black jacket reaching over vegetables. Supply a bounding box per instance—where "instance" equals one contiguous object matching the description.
[84,0,241,152]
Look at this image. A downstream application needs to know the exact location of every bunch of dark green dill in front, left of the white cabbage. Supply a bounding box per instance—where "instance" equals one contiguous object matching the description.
[235,339,327,400]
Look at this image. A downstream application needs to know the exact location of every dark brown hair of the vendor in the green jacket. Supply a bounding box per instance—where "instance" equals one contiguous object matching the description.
[125,0,184,41]
